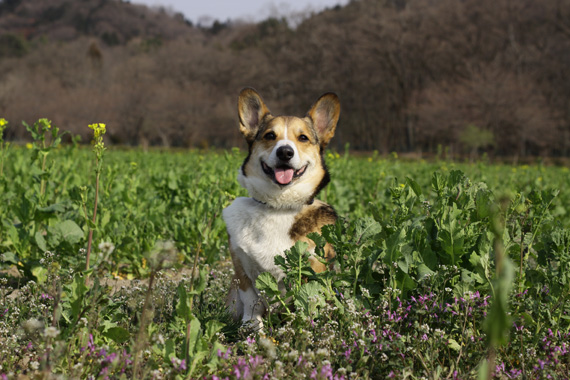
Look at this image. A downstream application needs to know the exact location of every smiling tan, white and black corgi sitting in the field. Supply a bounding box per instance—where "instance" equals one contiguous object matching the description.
[223,88,340,326]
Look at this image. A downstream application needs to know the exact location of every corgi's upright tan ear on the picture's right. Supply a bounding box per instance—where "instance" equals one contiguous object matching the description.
[307,92,340,148]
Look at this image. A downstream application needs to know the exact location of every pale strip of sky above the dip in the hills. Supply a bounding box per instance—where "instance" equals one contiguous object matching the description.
[131,0,349,23]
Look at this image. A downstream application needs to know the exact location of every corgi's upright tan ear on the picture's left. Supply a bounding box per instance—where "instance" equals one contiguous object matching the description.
[238,87,271,143]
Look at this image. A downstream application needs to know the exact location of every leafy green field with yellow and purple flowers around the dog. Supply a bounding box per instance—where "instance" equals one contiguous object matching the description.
[0,119,570,380]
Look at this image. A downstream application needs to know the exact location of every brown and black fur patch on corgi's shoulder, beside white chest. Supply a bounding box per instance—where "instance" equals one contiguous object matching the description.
[289,200,337,241]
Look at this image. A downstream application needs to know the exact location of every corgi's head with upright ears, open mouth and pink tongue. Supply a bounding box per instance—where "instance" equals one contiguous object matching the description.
[238,88,340,208]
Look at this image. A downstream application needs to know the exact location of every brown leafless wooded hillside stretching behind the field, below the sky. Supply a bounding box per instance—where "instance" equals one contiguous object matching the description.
[0,0,570,156]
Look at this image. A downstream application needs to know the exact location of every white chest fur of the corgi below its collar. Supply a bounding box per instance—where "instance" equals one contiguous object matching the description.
[223,197,299,283]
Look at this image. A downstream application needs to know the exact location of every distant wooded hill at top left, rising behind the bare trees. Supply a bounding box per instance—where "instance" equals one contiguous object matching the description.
[0,0,191,45]
